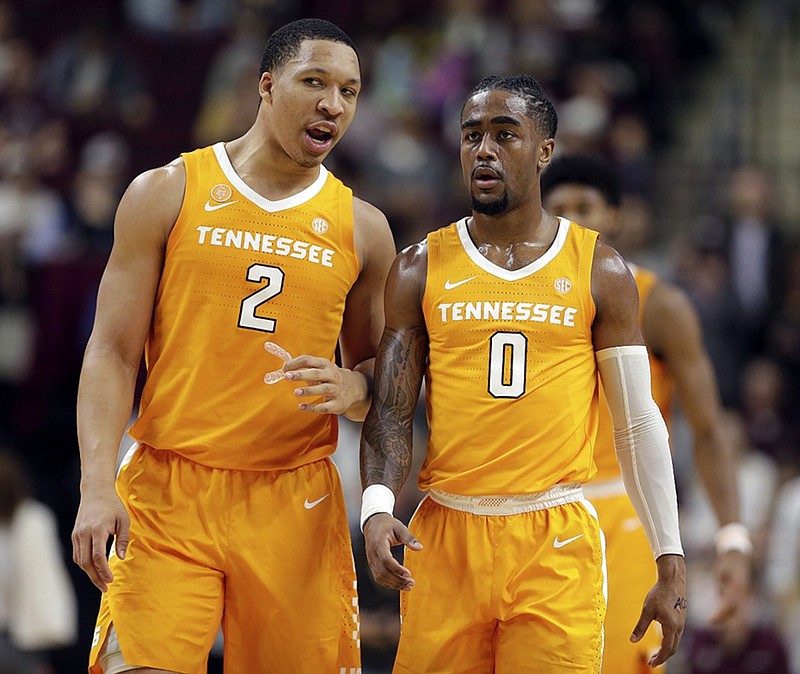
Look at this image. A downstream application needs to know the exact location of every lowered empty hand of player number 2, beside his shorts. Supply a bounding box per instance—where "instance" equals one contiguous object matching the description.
[72,487,130,592]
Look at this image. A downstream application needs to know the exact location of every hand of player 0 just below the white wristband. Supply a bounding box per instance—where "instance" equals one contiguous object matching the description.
[364,513,422,591]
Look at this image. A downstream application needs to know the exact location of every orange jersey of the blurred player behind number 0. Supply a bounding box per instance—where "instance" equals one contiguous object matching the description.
[594,264,673,481]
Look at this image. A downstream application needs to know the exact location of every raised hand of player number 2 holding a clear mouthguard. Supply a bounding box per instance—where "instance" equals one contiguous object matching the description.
[283,356,368,414]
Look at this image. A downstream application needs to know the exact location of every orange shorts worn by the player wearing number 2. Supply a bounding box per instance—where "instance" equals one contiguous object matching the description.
[90,446,360,674]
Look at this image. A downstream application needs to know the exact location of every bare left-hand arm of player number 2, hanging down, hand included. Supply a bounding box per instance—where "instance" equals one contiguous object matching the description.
[72,162,185,590]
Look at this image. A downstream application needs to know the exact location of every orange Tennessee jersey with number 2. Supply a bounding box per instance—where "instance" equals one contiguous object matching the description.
[131,143,359,470]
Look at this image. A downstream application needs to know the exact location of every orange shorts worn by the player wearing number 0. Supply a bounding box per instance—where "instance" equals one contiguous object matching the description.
[394,488,605,674]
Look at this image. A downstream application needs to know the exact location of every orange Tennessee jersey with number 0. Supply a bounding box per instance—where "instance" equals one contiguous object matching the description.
[420,218,598,496]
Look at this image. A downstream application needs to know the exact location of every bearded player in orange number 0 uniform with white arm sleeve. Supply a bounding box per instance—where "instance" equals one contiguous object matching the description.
[361,75,686,674]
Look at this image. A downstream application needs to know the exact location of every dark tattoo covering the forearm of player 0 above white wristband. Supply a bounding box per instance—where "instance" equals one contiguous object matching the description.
[361,326,428,493]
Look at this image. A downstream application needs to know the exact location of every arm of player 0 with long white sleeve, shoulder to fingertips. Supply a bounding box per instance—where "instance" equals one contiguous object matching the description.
[592,242,686,667]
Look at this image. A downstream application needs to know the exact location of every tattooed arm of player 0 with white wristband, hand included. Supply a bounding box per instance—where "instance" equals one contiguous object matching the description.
[361,244,428,590]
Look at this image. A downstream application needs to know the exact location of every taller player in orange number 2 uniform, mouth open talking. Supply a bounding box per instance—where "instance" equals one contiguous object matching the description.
[73,19,395,674]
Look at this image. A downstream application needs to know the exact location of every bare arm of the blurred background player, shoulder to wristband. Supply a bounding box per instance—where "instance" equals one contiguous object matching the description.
[642,283,739,525]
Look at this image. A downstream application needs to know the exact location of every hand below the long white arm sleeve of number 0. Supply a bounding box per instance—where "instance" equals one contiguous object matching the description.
[631,555,687,667]
